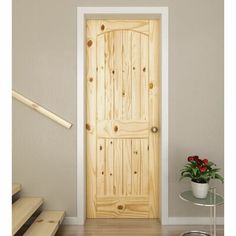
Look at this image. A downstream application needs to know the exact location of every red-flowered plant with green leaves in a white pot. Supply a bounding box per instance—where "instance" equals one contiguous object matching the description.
[180,156,224,198]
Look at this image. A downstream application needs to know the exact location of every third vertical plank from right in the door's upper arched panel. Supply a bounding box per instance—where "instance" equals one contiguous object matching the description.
[122,30,132,120]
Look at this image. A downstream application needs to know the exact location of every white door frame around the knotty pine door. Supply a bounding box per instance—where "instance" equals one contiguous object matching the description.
[77,7,168,225]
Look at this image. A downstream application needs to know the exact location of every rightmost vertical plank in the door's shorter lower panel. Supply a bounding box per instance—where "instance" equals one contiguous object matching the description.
[140,139,149,195]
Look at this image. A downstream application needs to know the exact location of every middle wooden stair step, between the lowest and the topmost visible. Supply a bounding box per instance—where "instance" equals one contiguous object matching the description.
[12,197,43,235]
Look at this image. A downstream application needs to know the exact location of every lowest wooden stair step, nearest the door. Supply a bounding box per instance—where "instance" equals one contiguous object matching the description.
[24,211,65,236]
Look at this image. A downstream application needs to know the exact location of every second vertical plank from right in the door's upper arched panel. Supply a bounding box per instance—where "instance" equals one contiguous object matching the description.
[132,32,141,119]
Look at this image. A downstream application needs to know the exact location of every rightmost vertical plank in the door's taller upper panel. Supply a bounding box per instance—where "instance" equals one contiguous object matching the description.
[140,34,149,120]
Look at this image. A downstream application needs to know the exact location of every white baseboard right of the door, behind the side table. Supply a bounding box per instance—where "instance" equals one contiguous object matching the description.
[167,217,224,225]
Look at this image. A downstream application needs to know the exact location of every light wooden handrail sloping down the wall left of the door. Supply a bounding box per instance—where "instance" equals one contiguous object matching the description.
[12,90,72,129]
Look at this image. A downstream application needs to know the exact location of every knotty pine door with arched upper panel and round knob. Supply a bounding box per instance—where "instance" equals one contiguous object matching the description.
[86,20,160,218]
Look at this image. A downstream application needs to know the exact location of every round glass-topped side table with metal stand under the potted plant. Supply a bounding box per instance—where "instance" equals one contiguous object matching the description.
[179,188,224,236]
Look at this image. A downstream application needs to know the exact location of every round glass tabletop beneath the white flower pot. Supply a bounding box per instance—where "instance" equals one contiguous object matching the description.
[179,190,224,207]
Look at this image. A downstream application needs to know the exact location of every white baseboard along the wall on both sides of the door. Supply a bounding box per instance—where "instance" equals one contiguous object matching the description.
[63,217,224,225]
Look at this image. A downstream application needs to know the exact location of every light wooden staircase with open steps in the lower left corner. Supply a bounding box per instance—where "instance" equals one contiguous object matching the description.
[12,184,65,236]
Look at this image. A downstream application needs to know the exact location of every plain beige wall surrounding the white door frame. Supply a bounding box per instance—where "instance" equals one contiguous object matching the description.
[13,0,224,216]
